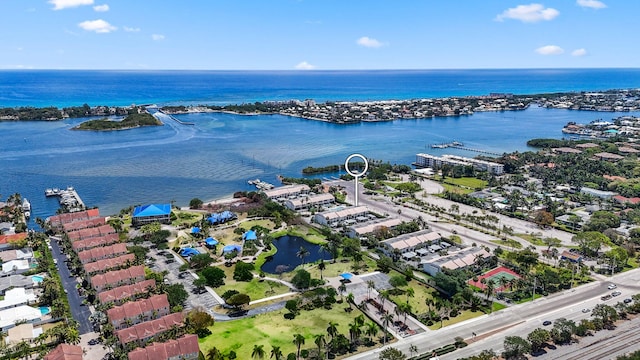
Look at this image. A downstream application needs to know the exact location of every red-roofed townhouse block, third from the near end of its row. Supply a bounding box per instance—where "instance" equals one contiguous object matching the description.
[107,294,170,330]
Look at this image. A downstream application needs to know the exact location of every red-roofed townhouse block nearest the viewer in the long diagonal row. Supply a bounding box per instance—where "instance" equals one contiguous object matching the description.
[129,334,200,360]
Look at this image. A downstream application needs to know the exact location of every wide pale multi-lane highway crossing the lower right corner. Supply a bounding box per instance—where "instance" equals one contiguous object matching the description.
[349,269,640,360]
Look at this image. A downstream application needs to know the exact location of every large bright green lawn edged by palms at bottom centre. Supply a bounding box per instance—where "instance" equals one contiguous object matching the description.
[199,304,376,359]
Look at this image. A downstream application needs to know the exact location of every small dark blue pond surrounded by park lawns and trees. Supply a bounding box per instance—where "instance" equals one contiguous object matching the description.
[262,235,331,274]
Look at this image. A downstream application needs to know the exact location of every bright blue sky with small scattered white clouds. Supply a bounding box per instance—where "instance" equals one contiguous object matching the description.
[0,0,640,70]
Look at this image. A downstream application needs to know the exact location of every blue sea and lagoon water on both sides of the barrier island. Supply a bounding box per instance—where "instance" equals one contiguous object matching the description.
[0,69,640,218]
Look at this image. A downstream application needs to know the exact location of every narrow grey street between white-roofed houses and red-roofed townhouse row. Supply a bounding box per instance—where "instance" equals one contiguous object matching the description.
[49,238,93,335]
